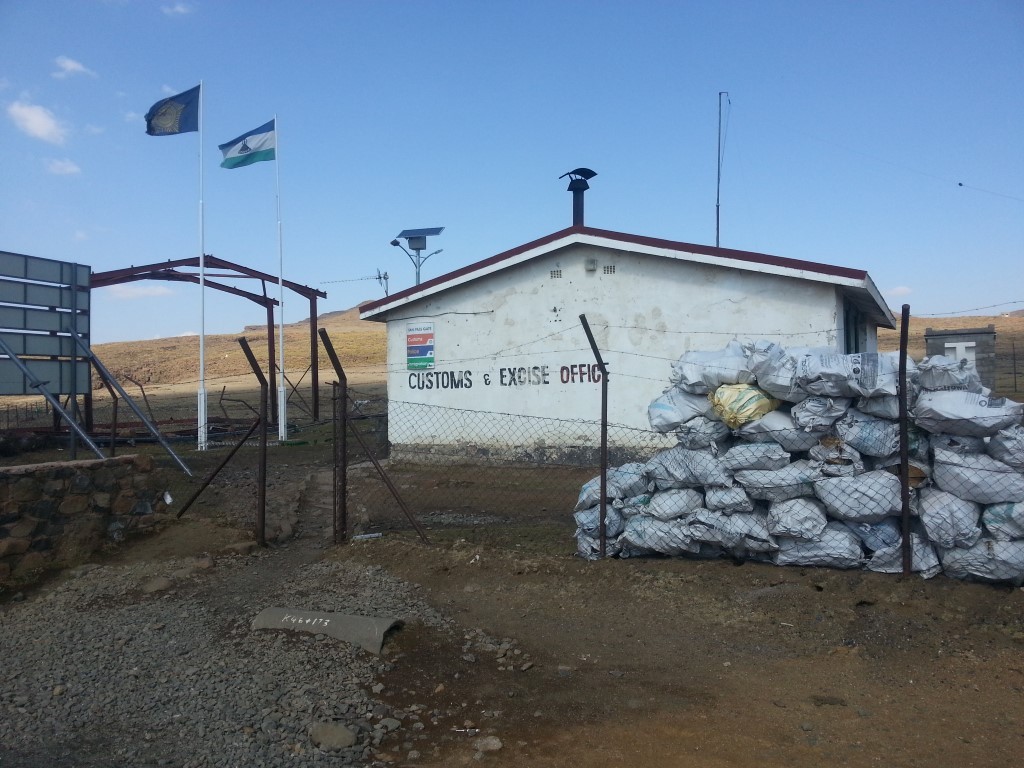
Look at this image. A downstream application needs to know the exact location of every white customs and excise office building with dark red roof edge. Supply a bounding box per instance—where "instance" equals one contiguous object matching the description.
[360,225,895,458]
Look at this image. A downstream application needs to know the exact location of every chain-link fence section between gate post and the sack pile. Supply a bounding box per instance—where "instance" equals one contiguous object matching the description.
[348,393,634,546]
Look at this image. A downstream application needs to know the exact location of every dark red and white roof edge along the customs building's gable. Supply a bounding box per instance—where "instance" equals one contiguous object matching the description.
[359,226,888,325]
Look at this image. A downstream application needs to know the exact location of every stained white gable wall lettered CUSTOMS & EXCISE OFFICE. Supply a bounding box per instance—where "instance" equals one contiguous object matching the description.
[387,244,842,454]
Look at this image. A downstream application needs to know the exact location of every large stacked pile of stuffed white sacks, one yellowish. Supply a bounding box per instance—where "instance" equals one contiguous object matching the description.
[575,340,1024,585]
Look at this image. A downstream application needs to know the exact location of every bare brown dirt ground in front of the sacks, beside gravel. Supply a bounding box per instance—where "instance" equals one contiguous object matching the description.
[6,309,1024,768]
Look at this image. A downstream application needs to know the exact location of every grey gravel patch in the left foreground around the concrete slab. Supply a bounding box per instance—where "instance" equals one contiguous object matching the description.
[0,528,451,768]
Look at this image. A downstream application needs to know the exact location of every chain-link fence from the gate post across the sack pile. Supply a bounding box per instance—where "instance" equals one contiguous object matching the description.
[339,325,1024,584]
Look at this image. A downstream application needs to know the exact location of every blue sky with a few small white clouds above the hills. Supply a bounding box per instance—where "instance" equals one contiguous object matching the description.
[0,0,1024,342]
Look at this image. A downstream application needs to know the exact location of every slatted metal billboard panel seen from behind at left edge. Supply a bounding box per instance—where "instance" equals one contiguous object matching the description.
[0,251,91,399]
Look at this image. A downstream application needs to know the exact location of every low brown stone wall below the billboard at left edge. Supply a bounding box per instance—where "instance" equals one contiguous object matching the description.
[0,456,167,582]
